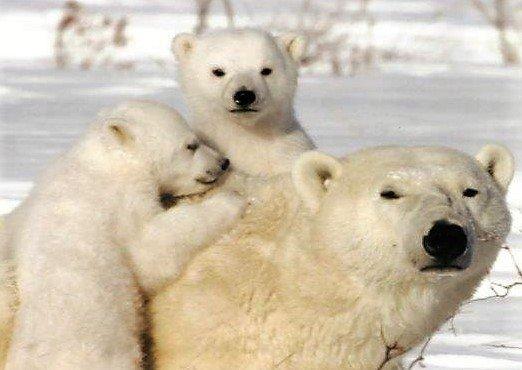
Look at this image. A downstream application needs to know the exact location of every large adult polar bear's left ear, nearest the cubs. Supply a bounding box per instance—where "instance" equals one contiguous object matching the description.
[292,151,342,212]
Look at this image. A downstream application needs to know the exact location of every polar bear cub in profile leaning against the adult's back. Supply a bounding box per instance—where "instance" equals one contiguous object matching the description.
[4,101,244,370]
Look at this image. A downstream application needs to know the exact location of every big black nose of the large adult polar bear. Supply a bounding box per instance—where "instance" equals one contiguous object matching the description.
[422,220,468,262]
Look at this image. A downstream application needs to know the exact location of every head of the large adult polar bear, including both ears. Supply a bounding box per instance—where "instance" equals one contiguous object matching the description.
[293,145,514,283]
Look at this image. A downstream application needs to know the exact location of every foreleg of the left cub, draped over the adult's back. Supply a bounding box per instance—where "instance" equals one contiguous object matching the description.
[129,193,245,293]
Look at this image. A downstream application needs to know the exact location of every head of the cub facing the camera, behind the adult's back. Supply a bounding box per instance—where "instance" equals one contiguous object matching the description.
[172,29,305,125]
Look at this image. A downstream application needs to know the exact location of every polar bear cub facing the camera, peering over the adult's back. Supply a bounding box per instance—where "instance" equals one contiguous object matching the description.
[172,29,313,176]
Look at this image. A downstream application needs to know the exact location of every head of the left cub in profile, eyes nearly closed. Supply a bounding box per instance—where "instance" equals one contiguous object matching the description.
[96,101,230,196]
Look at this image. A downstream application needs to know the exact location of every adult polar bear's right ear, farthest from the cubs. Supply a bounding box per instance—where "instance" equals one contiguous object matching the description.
[475,144,515,192]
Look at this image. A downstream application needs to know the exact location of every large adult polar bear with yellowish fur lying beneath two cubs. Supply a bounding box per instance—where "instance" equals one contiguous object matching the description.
[152,145,514,370]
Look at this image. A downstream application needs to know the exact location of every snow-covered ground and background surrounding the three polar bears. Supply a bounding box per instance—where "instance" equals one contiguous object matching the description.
[0,0,522,369]
